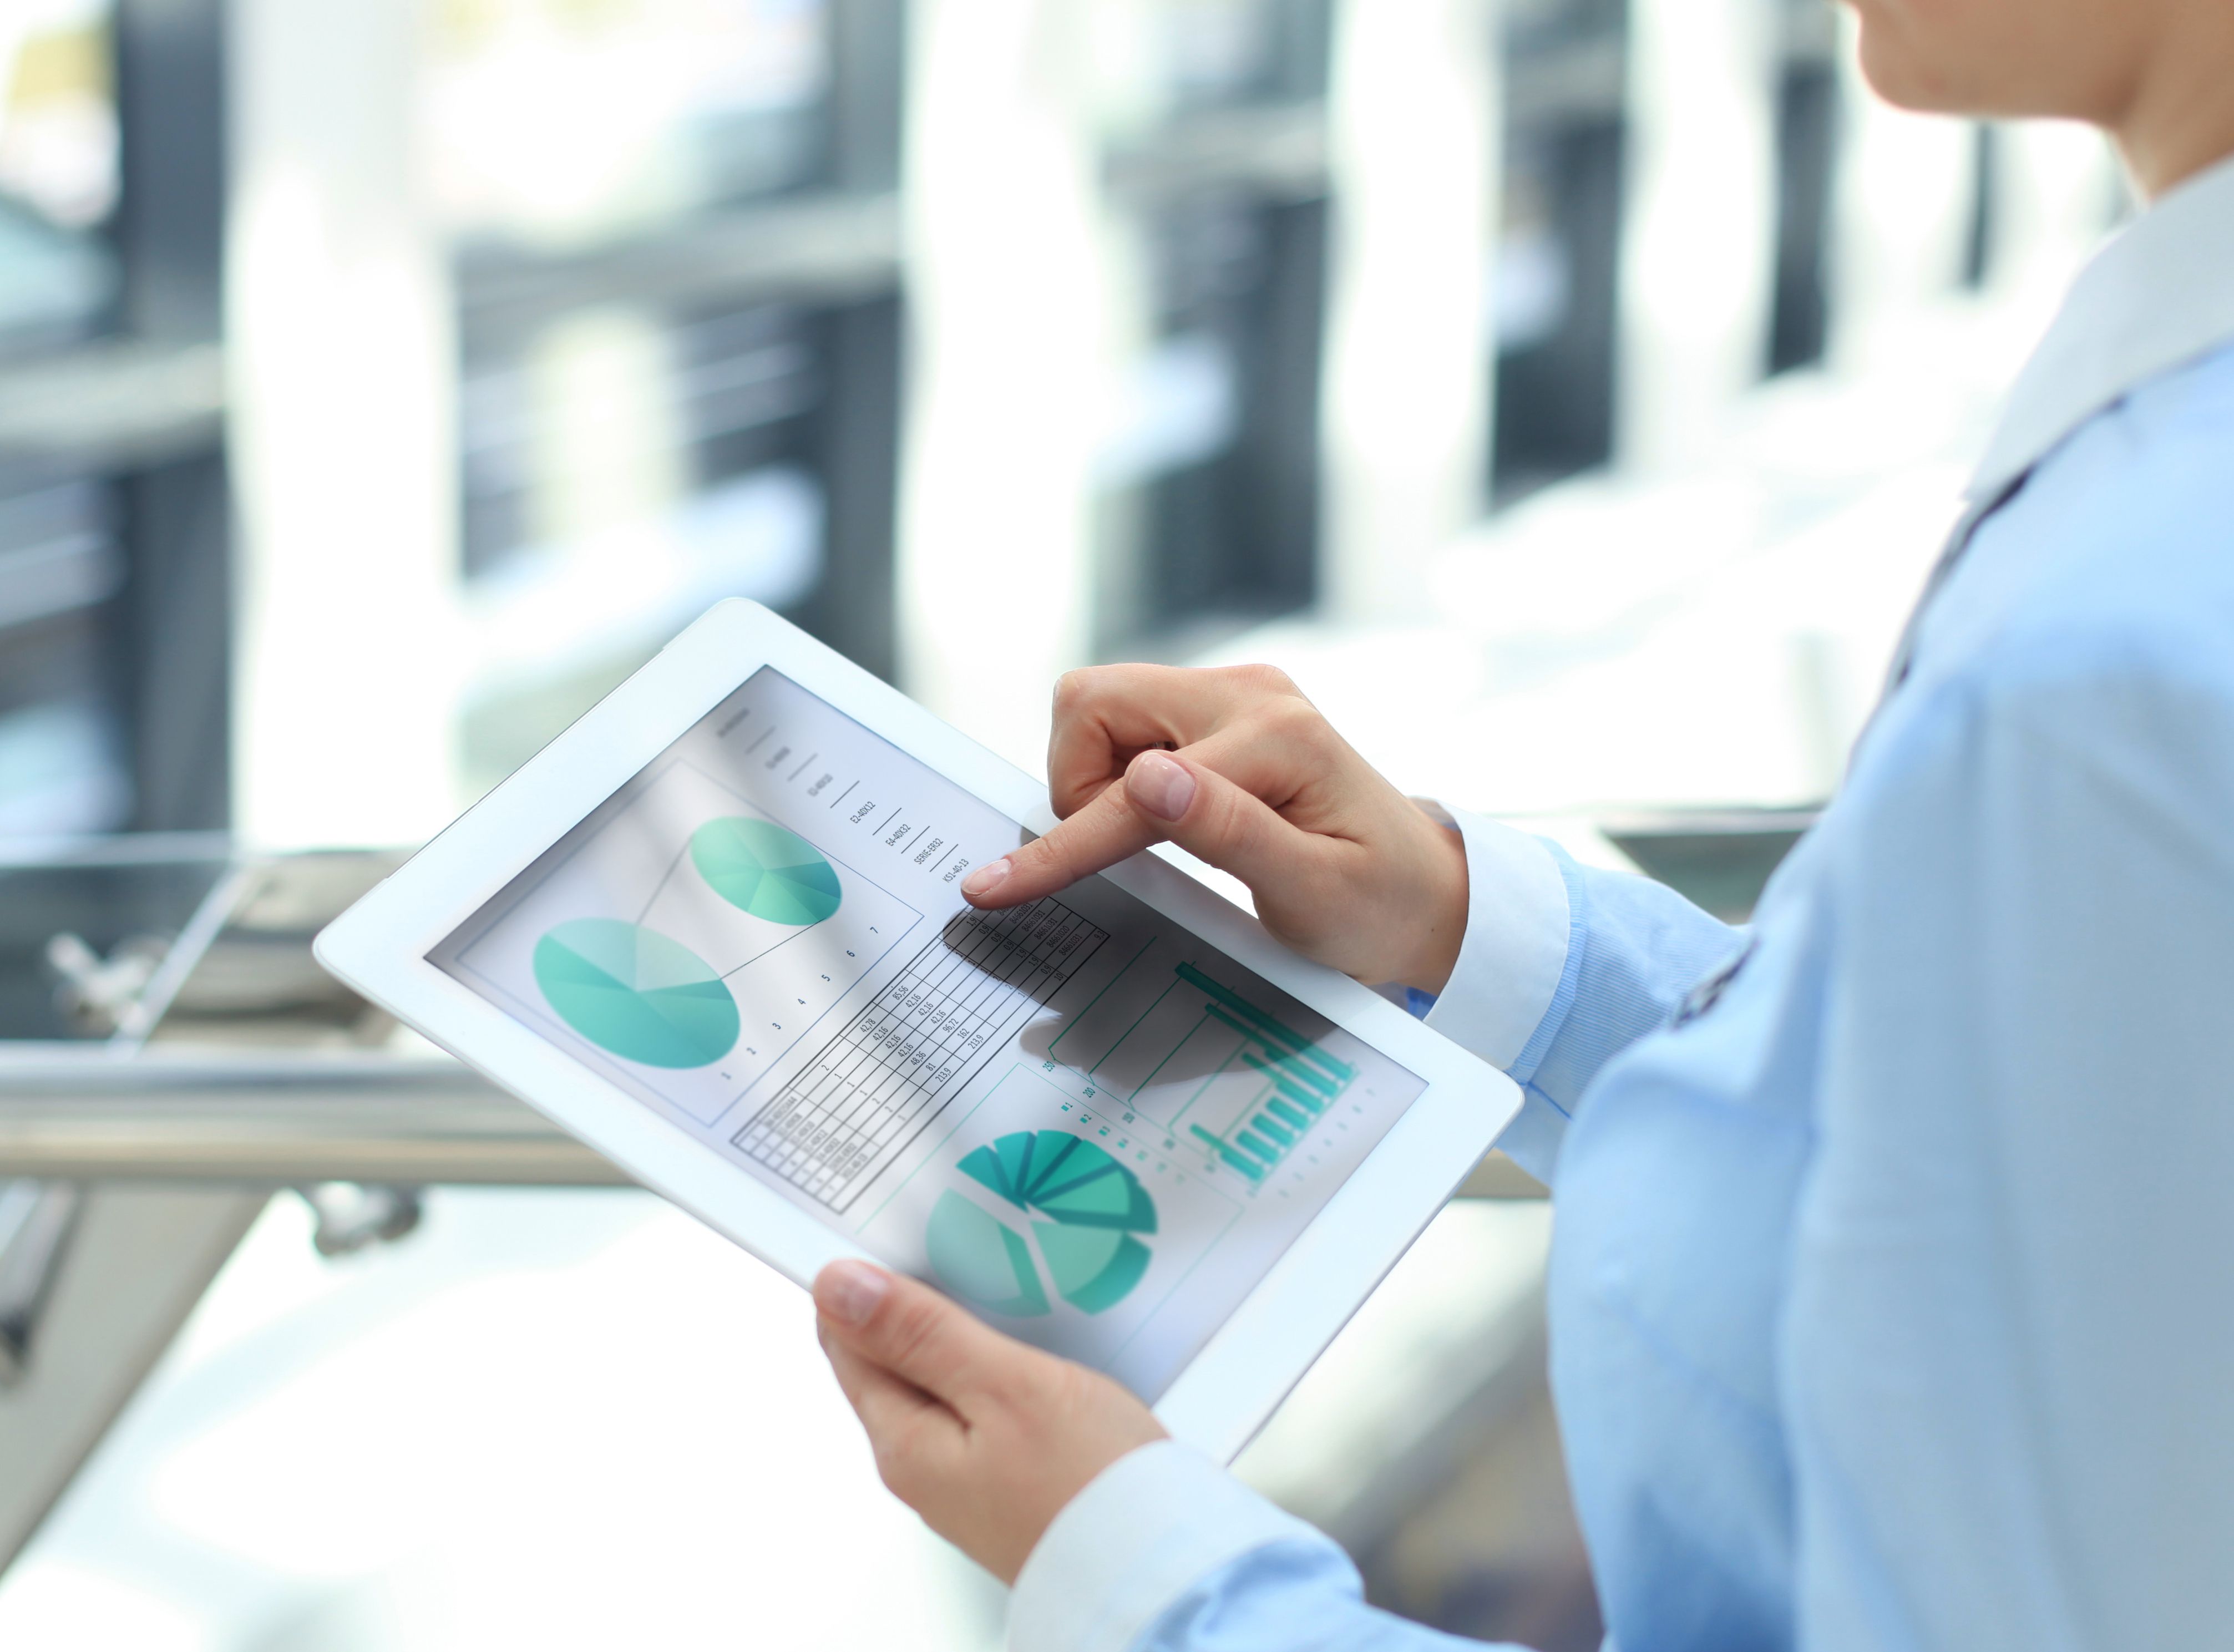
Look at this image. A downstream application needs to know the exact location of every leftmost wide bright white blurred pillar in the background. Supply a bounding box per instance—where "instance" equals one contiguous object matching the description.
[226,0,463,846]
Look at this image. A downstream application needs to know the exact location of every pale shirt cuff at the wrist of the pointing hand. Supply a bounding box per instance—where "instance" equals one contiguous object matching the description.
[1425,810,1568,1072]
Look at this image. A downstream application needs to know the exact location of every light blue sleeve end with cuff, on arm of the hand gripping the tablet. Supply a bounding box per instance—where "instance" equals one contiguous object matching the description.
[1007,1440,1519,1652]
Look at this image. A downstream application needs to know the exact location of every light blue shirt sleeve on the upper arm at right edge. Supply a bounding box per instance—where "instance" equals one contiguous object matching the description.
[1781,619,2234,1652]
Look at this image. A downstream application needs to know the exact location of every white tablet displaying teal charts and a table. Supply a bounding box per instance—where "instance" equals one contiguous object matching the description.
[317,601,1519,1458]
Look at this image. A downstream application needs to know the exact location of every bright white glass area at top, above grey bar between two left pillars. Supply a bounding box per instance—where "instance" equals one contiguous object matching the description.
[424,0,831,246]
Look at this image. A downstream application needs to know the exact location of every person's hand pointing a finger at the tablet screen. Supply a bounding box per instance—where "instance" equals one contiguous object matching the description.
[963,665,1466,991]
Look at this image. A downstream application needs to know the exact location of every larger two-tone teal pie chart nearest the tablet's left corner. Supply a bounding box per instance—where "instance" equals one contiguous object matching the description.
[534,918,737,1067]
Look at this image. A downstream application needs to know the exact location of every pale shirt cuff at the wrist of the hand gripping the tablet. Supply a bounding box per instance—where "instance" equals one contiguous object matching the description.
[1007,1440,1327,1652]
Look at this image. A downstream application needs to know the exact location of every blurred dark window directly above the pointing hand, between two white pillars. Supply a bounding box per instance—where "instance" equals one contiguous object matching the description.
[1095,0,1331,654]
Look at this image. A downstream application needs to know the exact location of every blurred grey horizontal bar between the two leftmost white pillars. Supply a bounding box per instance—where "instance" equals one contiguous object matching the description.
[458,192,900,333]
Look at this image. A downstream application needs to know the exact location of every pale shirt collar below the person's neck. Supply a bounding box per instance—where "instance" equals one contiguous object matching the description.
[1968,159,2234,504]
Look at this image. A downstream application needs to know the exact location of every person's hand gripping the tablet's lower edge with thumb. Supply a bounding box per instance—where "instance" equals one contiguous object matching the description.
[815,1261,1164,1583]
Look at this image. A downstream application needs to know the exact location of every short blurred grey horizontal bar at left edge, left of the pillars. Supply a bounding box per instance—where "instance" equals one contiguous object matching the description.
[0,342,226,471]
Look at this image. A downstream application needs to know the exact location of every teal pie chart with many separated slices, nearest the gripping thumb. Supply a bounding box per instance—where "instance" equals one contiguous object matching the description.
[925,1129,1155,1319]
